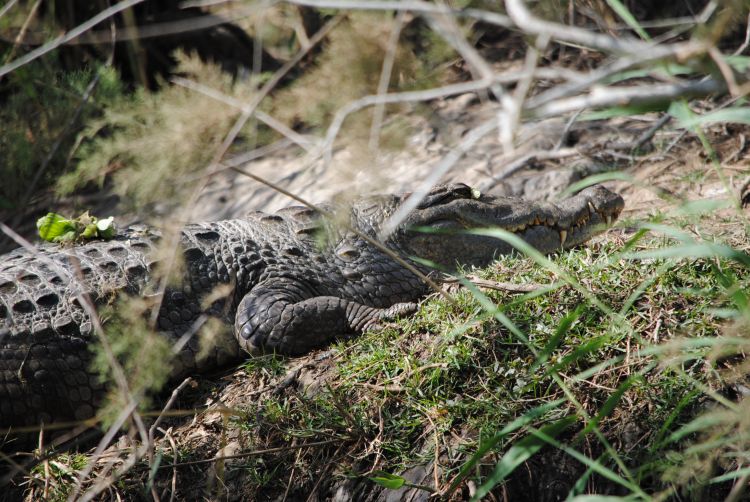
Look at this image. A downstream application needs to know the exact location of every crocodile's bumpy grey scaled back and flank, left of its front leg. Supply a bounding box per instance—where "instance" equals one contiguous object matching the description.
[0,215,322,428]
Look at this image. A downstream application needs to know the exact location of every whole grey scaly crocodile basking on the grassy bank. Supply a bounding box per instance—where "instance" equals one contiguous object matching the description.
[0,184,623,429]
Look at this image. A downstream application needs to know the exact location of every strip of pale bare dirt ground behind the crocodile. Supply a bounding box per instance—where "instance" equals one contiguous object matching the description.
[187,94,750,229]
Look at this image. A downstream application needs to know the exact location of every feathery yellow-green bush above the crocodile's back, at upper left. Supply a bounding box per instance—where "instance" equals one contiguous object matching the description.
[58,55,262,212]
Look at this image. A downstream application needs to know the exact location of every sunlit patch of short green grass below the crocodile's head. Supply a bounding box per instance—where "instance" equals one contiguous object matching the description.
[214,215,748,500]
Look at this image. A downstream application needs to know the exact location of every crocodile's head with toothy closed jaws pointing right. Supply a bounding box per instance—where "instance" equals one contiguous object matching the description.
[390,184,624,268]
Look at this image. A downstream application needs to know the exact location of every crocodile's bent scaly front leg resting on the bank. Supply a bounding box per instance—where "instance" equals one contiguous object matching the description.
[234,279,417,355]
